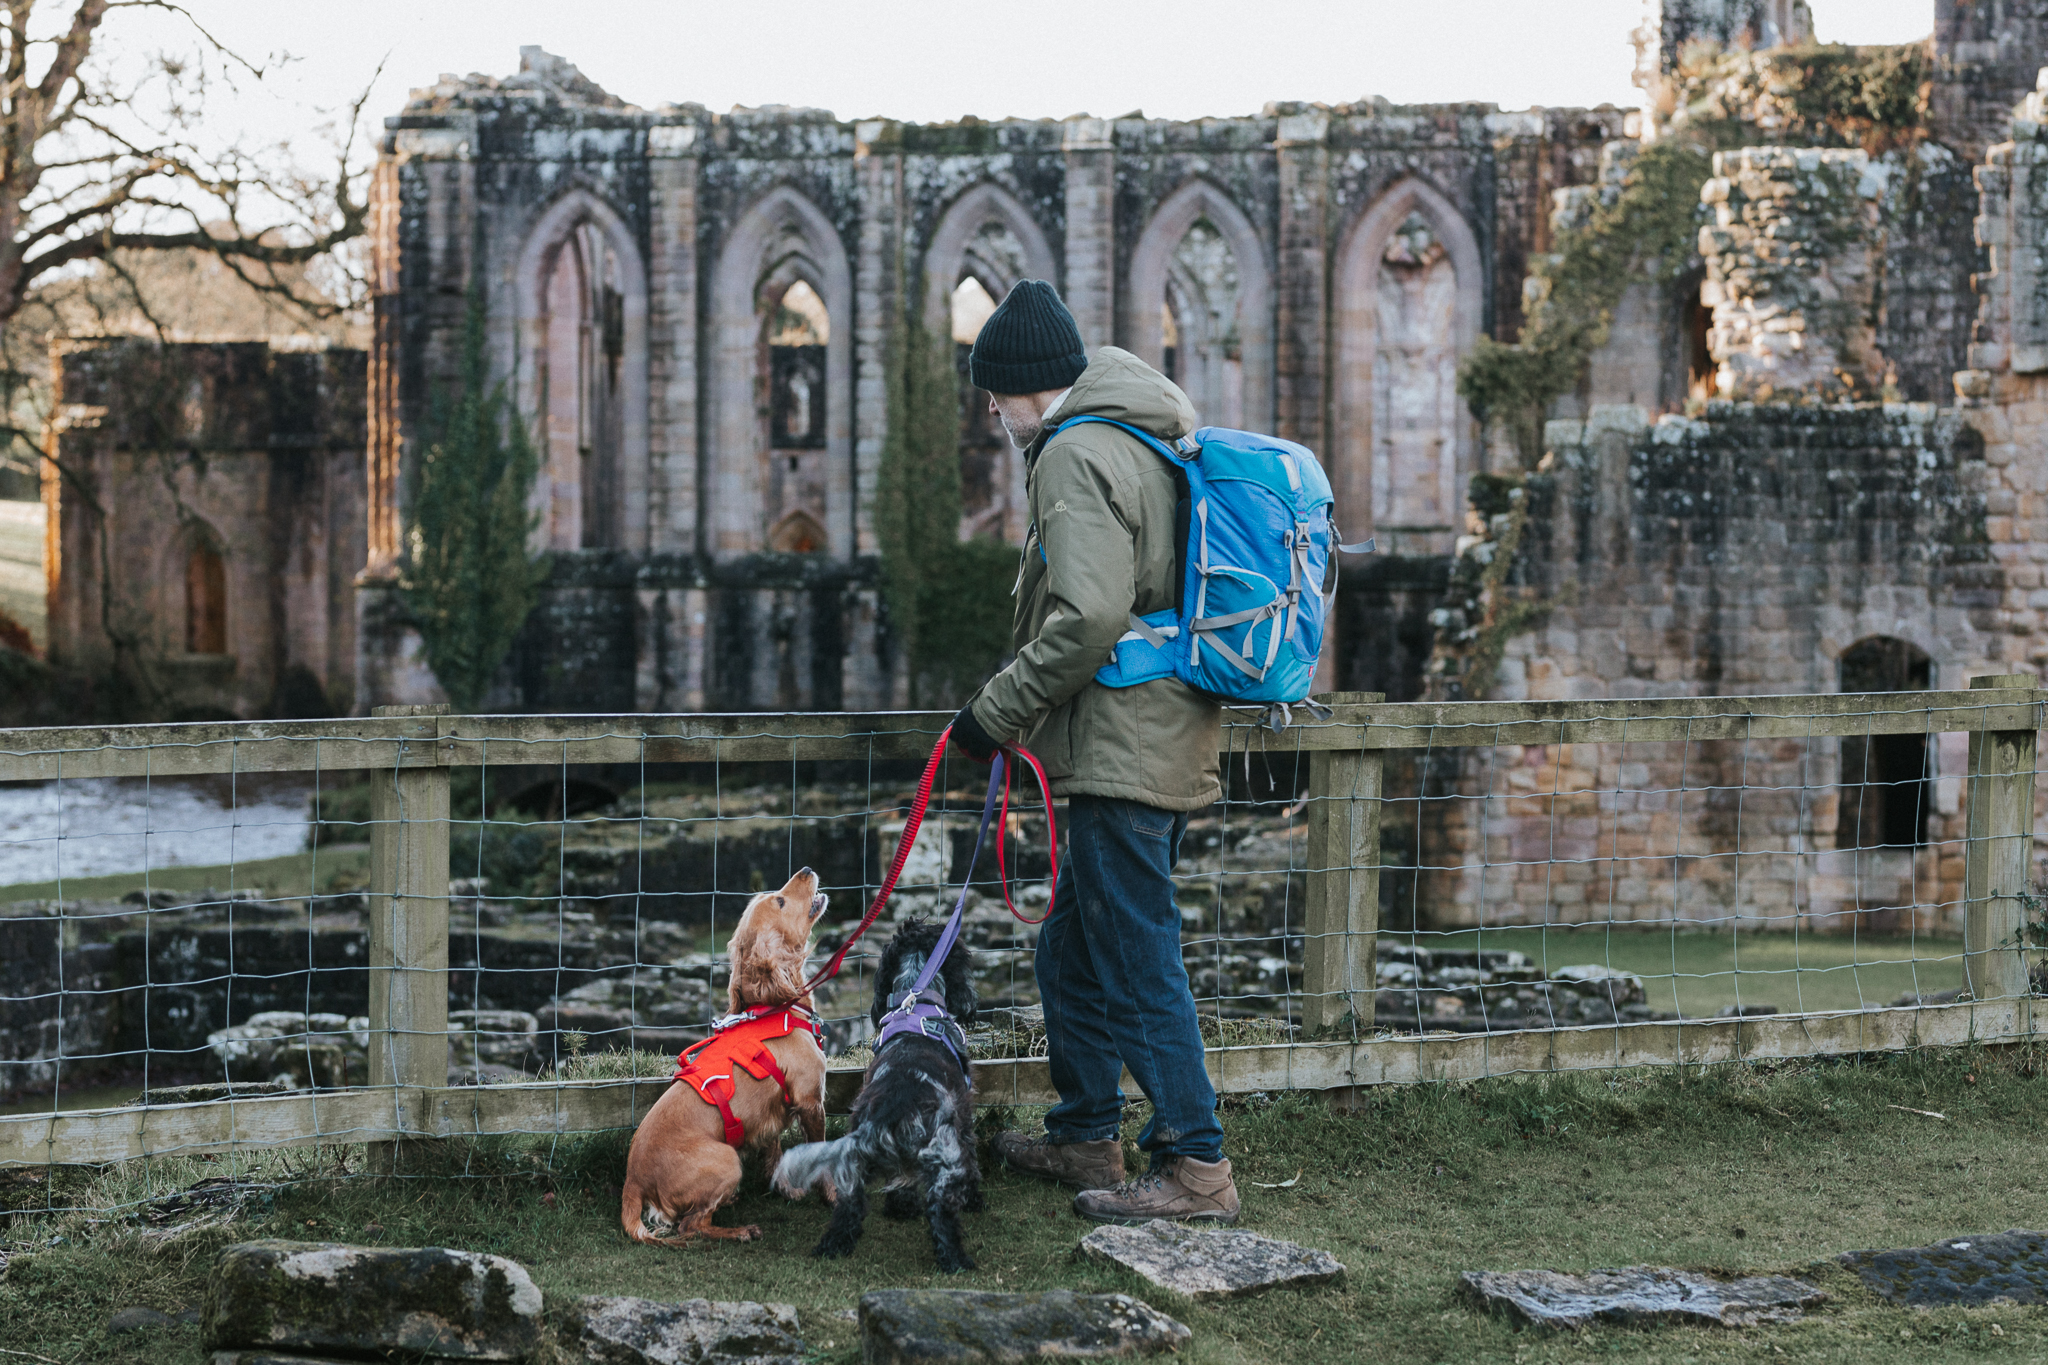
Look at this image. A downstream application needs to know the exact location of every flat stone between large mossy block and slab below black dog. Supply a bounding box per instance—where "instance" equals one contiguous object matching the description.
[567,1295,803,1365]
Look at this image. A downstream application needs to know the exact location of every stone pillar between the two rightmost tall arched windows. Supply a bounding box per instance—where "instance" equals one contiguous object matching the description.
[1274,108,1329,450]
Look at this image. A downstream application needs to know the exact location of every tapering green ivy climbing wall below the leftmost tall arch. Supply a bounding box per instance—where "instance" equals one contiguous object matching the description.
[399,289,547,710]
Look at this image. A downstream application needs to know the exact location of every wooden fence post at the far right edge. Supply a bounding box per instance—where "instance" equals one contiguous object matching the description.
[1962,673,2034,1001]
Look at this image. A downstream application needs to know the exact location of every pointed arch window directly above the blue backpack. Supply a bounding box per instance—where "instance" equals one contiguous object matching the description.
[1124,180,1274,430]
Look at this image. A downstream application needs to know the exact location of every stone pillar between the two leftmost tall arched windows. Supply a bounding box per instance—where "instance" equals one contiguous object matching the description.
[647,123,698,555]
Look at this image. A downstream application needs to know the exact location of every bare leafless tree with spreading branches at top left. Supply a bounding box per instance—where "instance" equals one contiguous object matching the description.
[0,0,375,708]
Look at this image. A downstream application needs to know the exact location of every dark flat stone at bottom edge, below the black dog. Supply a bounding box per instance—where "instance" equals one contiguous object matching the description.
[860,1289,1192,1365]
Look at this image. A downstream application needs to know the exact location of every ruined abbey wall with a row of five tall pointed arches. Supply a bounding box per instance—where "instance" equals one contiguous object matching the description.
[356,49,1626,710]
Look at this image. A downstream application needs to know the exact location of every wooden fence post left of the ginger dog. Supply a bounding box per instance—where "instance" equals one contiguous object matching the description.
[369,706,449,1173]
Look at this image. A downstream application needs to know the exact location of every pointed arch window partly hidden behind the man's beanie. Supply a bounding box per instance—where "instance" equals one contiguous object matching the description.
[924,182,1057,540]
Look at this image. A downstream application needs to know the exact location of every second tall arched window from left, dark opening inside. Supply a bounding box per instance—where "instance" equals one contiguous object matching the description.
[705,186,854,557]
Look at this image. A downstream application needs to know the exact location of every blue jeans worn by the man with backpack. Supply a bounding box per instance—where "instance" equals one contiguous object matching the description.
[1036,796,1223,1169]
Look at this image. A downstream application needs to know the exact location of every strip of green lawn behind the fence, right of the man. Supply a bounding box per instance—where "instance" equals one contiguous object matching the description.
[1386,925,1962,1017]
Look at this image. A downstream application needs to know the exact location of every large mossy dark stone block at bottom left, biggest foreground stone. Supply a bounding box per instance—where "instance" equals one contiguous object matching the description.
[205,1242,541,1361]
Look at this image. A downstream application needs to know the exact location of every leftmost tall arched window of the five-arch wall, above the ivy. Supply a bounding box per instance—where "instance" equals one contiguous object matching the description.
[518,190,647,551]
